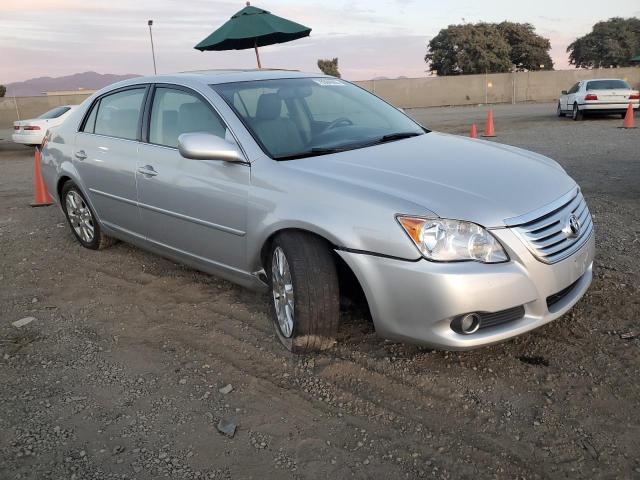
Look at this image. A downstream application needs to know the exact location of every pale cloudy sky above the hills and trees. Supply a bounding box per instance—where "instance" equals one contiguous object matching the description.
[0,0,640,84]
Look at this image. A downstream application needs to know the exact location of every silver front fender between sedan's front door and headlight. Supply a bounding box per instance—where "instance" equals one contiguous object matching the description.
[247,159,434,271]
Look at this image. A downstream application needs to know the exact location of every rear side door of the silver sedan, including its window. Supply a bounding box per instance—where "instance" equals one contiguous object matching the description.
[73,85,148,237]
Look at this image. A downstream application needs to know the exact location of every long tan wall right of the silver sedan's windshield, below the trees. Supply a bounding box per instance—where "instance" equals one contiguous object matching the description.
[355,67,640,108]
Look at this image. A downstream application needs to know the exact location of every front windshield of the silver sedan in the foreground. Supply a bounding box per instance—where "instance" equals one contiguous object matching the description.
[211,77,428,160]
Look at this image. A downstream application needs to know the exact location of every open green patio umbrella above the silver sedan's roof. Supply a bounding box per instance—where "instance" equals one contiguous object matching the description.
[194,2,311,68]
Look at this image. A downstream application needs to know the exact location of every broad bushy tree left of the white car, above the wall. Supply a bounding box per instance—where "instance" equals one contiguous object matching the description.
[425,22,553,75]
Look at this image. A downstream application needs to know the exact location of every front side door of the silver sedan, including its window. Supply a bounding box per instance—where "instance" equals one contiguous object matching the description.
[136,85,251,270]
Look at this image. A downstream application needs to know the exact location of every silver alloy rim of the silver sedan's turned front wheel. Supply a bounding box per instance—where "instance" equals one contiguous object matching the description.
[271,247,294,338]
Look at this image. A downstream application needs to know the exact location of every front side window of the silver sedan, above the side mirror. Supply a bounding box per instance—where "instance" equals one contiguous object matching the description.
[149,87,227,147]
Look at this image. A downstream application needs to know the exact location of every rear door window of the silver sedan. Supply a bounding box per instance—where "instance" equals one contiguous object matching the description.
[92,88,145,140]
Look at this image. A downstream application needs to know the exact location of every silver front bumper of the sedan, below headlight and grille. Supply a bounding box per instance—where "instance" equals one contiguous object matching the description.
[337,229,595,350]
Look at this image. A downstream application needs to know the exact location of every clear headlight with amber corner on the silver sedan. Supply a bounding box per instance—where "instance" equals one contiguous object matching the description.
[397,216,509,263]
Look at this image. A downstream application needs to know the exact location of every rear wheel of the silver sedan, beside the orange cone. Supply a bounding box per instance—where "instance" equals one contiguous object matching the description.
[60,181,115,250]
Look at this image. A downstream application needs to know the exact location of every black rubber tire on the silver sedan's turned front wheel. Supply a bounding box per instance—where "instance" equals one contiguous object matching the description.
[266,232,340,354]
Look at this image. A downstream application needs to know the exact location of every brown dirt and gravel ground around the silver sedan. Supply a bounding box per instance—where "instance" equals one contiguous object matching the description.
[0,105,640,479]
